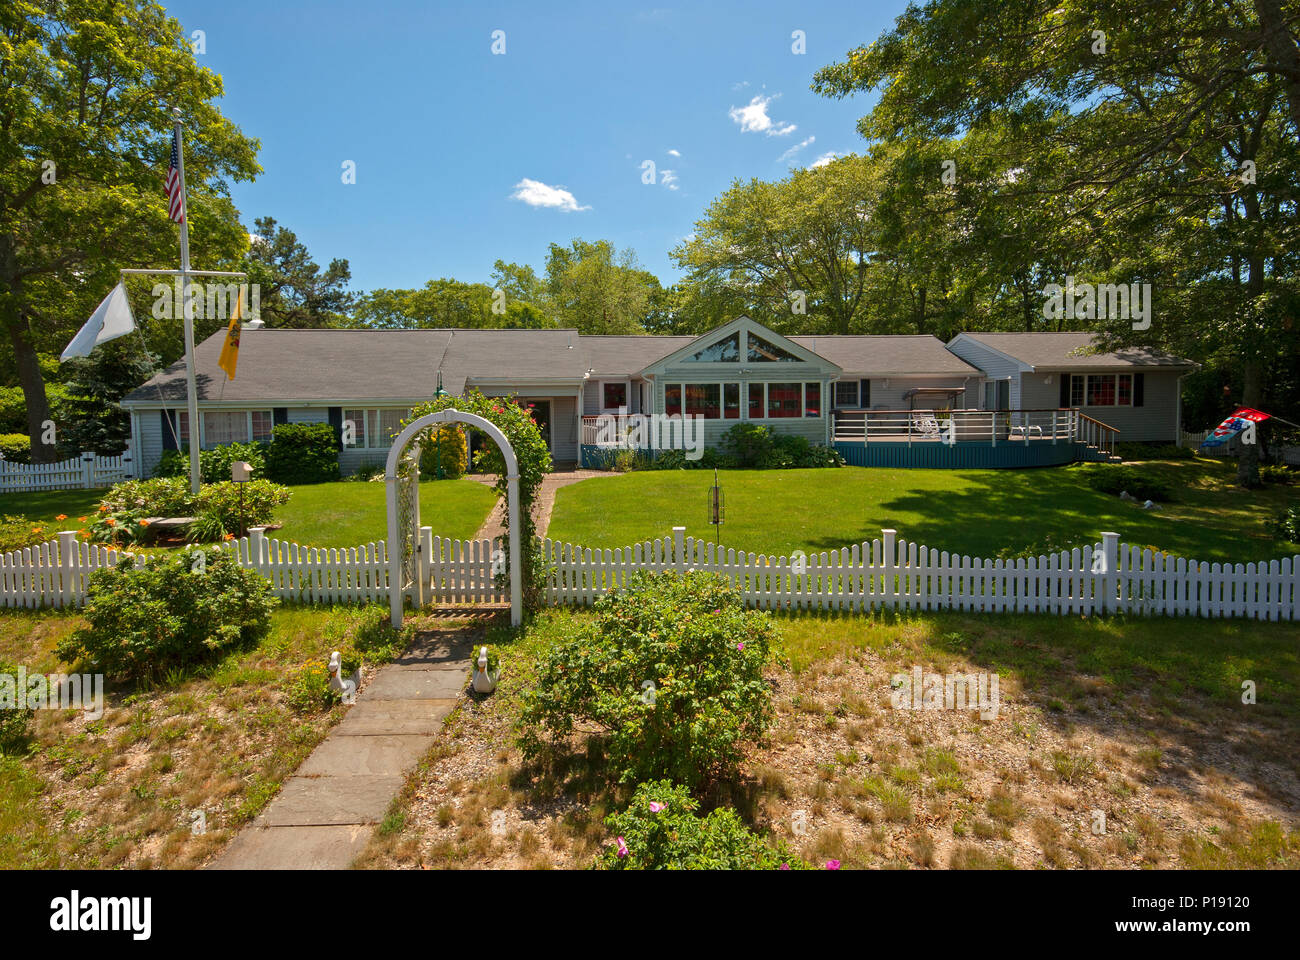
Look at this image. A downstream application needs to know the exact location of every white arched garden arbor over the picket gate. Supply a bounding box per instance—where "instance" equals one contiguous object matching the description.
[384,408,524,628]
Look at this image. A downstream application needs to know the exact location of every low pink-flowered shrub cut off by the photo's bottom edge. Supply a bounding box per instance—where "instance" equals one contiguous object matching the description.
[598,780,807,870]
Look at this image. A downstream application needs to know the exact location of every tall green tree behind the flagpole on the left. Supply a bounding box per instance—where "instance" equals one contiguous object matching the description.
[0,0,260,460]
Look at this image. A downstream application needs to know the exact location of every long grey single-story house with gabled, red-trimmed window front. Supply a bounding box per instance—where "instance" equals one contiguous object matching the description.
[121,316,1192,475]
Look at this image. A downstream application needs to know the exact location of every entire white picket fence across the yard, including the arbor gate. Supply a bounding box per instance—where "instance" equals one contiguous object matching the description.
[0,527,1300,620]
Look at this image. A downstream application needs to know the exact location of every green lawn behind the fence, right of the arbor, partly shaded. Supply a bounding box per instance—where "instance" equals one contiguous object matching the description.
[549,459,1300,562]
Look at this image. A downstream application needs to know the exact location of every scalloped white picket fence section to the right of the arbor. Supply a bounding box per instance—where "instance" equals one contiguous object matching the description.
[542,527,1300,620]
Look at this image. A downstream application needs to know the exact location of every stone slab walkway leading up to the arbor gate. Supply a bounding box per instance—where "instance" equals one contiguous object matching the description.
[211,618,484,870]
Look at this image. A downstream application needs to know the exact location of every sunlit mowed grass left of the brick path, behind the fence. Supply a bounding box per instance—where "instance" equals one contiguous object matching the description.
[0,479,497,546]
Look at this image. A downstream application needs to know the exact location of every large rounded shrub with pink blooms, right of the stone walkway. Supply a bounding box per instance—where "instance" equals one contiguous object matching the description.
[521,574,776,787]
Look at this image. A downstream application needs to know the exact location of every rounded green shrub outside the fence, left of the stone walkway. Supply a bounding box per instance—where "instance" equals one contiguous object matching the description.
[57,550,276,680]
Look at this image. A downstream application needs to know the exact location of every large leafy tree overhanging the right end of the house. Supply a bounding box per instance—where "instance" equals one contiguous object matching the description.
[813,0,1300,485]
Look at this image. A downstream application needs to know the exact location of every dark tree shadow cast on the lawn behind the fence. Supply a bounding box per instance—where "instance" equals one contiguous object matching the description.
[809,468,1290,563]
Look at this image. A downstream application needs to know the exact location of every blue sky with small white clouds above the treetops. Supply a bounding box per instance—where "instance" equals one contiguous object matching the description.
[165,0,904,290]
